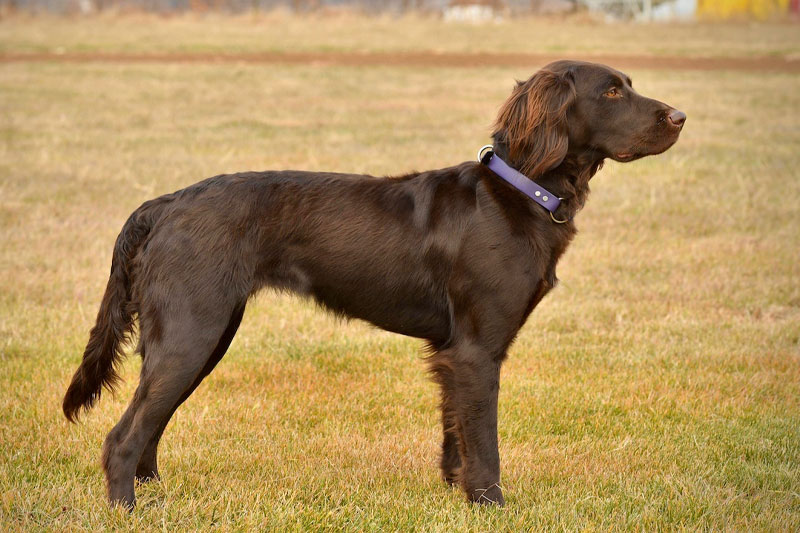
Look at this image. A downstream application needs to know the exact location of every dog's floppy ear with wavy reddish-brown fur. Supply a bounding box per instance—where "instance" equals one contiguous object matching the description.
[492,70,575,177]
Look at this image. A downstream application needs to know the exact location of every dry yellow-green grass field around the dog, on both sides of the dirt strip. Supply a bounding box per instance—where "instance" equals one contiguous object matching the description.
[0,11,800,531]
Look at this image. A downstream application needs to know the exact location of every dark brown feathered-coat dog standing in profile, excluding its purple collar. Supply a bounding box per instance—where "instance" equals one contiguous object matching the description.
[63,61,686,506]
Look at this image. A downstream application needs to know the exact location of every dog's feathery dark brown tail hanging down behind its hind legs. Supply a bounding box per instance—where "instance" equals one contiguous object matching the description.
[62,197,165,422]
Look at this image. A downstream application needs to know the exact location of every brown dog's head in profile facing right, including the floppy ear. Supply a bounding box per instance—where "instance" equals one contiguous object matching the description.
[493,61,686,176]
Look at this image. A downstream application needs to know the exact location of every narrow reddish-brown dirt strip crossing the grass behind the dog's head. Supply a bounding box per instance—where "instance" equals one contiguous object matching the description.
[0,52,800,72]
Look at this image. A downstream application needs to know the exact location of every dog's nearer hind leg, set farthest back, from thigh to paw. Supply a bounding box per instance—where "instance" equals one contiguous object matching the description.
[103,301,244,508]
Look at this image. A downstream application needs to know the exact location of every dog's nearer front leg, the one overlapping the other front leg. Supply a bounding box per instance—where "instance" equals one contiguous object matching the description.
[431,343,505,505]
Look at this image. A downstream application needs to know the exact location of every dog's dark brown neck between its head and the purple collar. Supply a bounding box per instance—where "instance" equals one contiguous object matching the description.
[494,137,603,218]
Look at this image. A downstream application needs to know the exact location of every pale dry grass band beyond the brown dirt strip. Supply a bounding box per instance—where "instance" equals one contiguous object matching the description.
[0,11,800,58]
